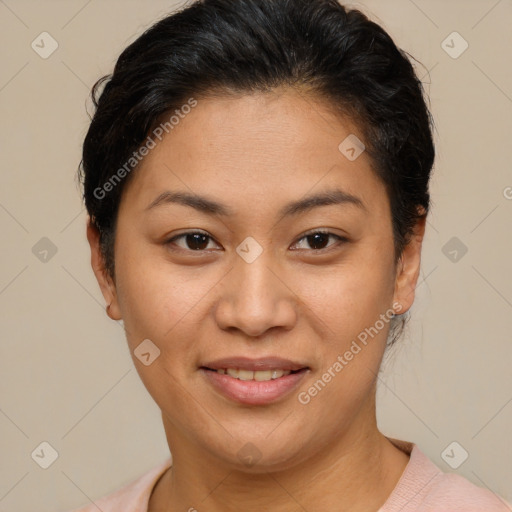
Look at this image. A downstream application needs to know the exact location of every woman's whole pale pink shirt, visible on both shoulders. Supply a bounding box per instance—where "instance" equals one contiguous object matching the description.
[72,439,512,512]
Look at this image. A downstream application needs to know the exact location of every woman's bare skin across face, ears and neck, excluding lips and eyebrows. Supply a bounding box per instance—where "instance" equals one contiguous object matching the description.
[87,89,425,512]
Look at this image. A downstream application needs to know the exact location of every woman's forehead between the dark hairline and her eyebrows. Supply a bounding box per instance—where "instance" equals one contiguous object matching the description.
[117,90,384,216]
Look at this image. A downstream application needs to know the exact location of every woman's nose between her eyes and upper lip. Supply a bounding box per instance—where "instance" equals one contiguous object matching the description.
[215,251,298,337]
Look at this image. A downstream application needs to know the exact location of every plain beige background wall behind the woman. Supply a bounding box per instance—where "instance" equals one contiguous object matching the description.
[0,0,512,512]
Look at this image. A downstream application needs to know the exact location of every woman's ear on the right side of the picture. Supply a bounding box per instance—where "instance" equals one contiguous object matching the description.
[394,210,427,314]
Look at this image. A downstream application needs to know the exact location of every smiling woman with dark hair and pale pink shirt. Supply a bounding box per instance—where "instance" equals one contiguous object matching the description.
[70,0,508,512]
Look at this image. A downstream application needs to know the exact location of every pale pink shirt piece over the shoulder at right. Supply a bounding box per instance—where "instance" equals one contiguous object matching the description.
[379,439,512,512]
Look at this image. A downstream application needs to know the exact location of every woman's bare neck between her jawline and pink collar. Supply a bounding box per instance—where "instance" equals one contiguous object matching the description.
[149,396,409,512]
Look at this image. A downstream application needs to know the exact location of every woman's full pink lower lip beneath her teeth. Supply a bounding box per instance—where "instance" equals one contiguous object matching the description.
[200,368,307,405]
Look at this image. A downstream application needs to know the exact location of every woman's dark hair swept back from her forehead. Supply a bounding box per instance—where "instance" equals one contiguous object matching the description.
[79,0,435,346]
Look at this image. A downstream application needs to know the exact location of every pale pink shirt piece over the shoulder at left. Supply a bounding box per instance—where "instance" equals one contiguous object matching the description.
[64,458,172,512]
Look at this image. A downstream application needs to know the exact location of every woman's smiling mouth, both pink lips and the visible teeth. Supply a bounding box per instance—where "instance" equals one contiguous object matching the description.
[199,358,311,405]
